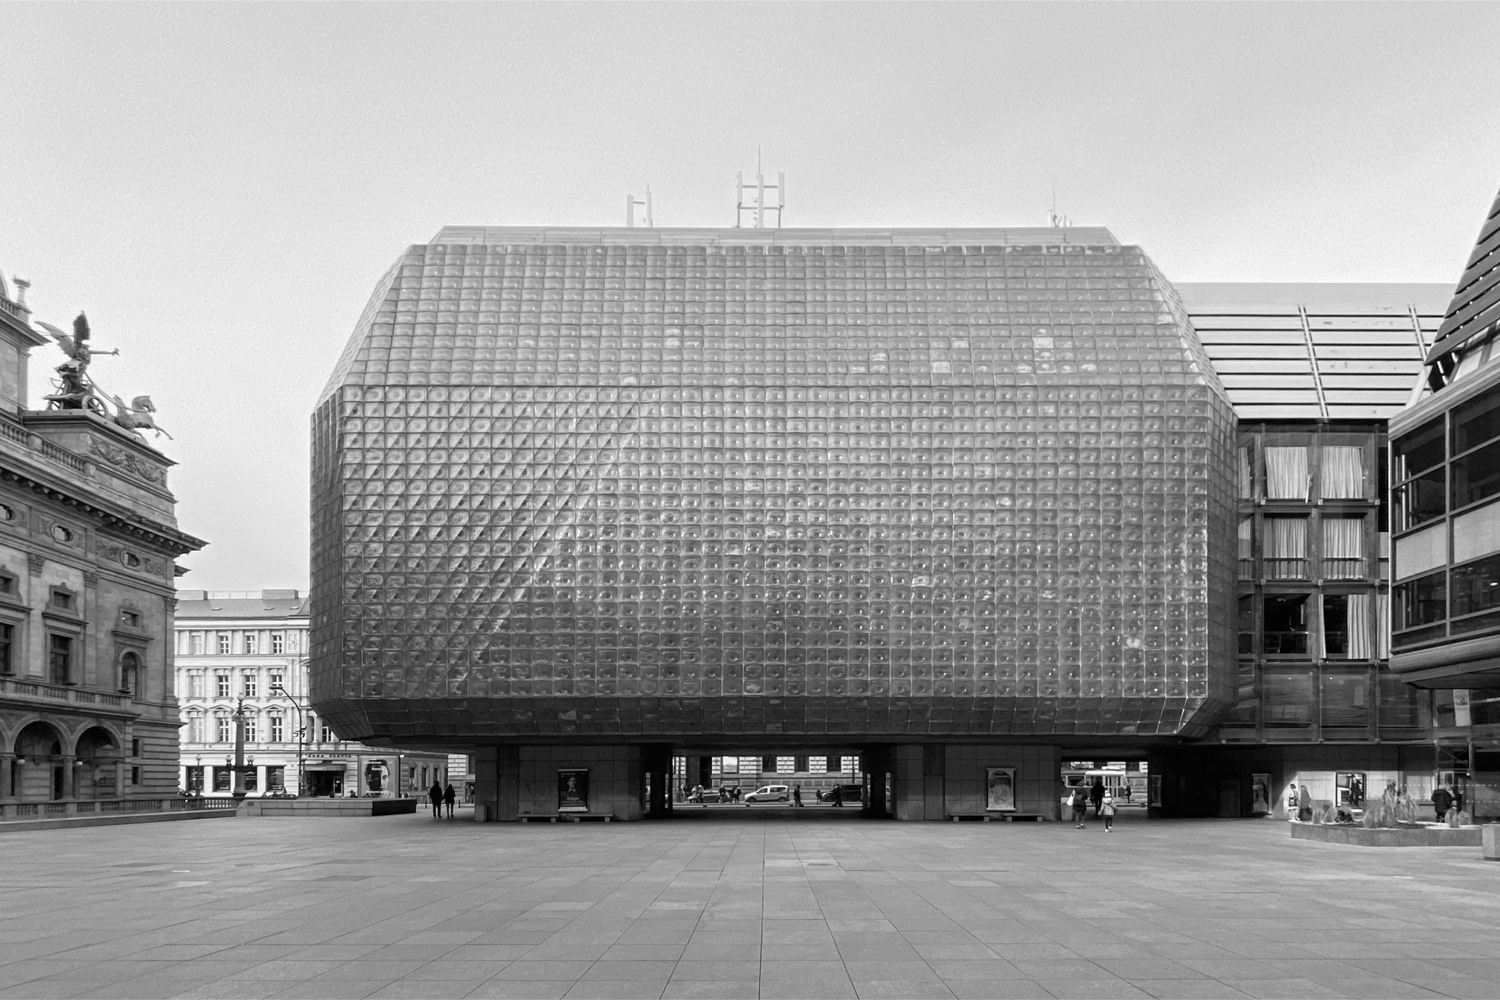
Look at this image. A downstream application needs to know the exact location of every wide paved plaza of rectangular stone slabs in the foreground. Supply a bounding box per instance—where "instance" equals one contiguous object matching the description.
[0,808,1500,1000]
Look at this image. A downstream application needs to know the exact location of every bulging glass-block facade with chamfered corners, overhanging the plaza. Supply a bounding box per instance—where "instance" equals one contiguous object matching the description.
[312,229,1236,744]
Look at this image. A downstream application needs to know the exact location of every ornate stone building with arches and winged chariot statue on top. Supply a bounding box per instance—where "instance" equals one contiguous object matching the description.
[0,268,204,819]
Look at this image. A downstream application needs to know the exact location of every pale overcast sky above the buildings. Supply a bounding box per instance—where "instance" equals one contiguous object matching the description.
[0,3,1500,589]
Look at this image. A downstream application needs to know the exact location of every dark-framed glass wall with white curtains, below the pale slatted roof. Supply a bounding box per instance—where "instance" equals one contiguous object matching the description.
[1220,423,1430,742]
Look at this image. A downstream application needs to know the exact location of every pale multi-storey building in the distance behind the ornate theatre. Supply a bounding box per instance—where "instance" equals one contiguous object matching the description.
[176,591,450,798]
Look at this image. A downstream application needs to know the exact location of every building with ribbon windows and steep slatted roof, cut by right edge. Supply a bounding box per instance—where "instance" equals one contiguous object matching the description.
[1391,183,1500,819]
